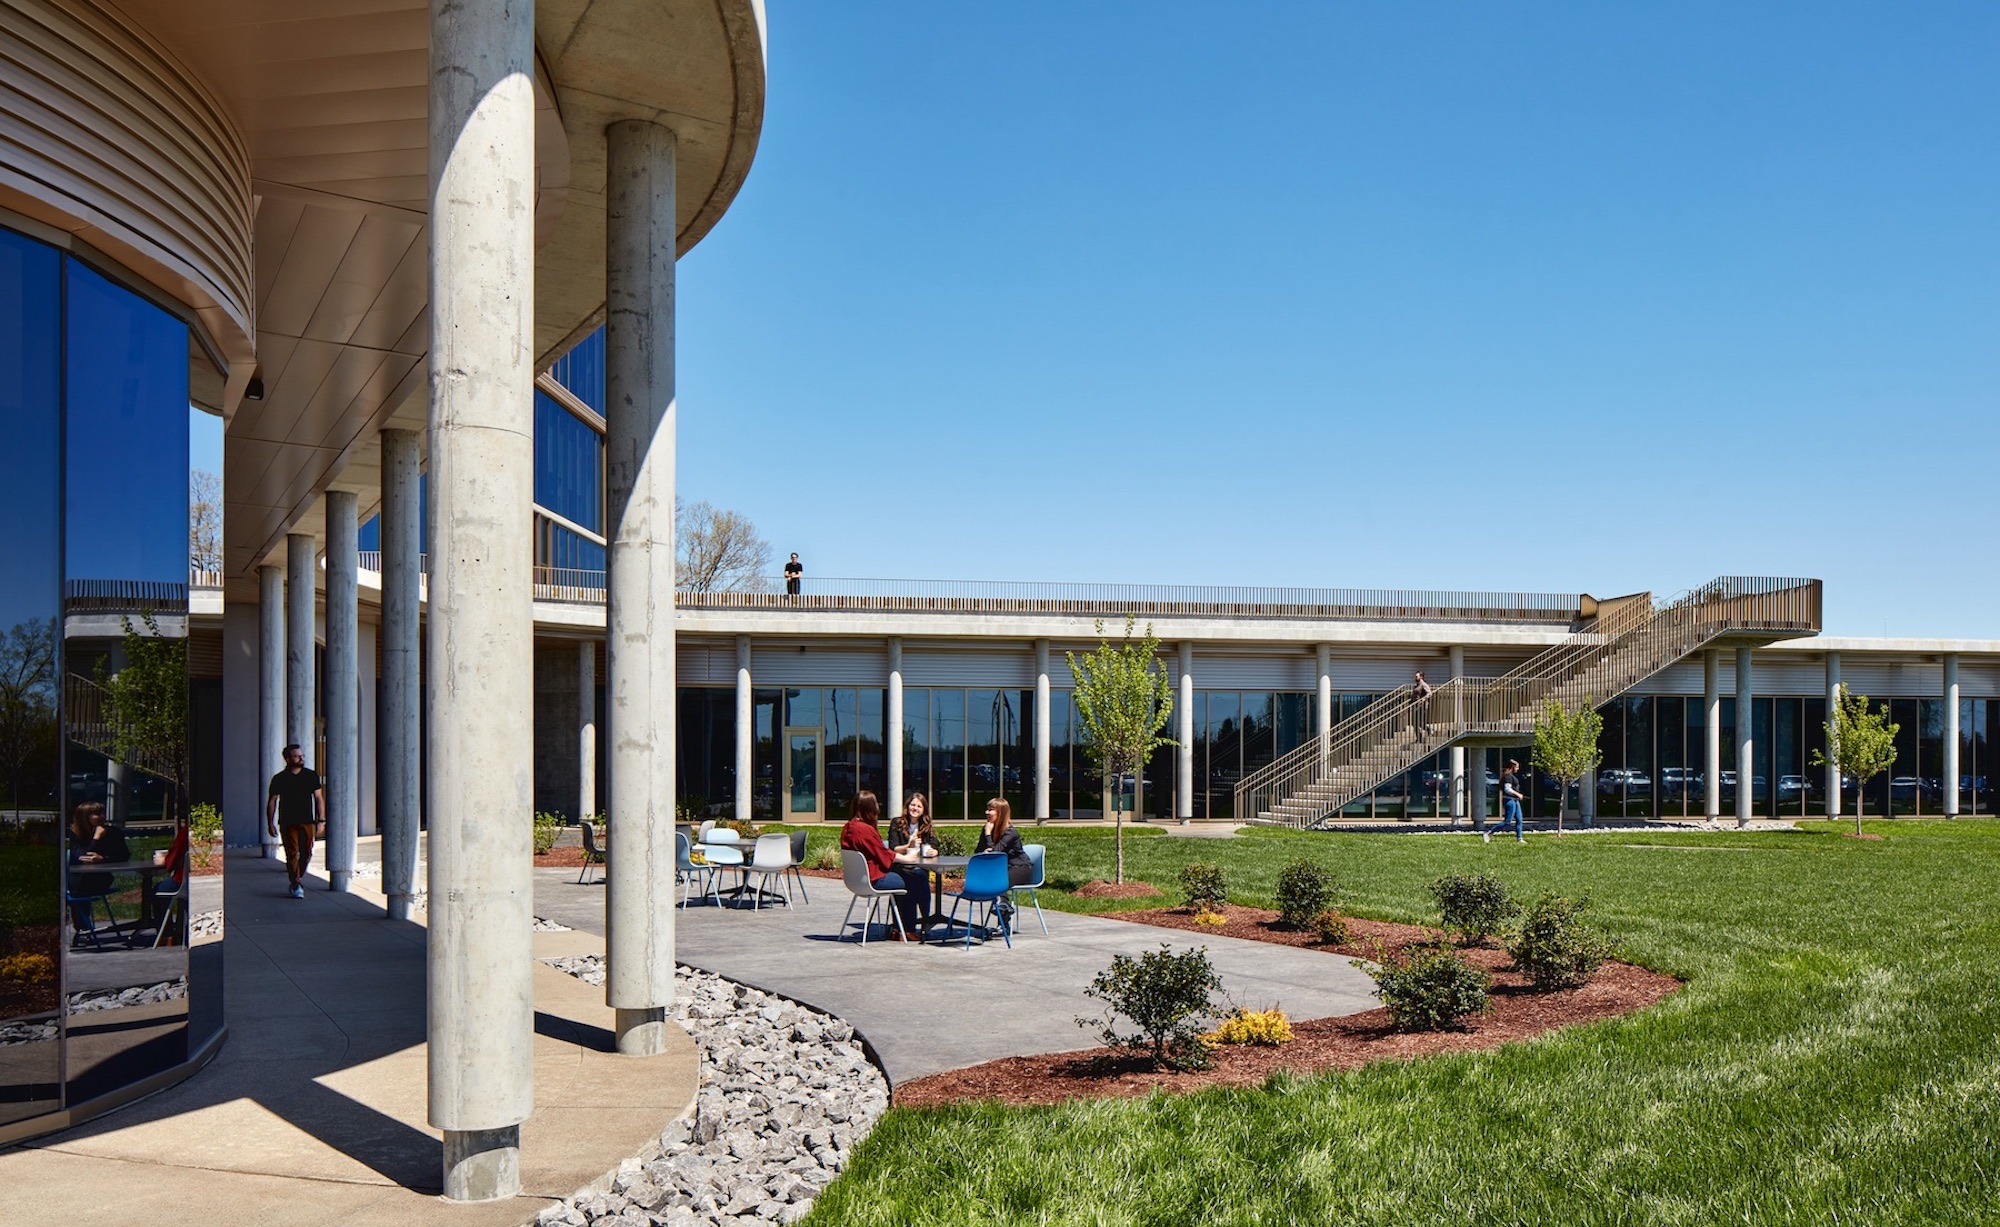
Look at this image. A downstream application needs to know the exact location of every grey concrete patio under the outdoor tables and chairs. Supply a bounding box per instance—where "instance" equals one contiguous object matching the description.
[534,869,1378,1085]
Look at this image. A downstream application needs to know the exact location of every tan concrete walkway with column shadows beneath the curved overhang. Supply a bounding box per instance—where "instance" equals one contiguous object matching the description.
[0,853,698,1227]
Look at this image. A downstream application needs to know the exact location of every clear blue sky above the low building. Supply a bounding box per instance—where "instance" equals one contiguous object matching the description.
[680,9,2000,637]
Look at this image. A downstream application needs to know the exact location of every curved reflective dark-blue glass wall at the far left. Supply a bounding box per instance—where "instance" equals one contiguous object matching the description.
[0,223,222,1125]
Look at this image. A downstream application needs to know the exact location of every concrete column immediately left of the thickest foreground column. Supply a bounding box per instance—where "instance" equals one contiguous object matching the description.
[380,430,424,919]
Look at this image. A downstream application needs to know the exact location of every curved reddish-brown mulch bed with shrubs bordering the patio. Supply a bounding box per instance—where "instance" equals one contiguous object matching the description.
[896,905,1680,1107]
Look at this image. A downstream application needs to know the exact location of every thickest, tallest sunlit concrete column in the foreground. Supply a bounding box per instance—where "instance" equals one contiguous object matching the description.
[424,0,536,1201]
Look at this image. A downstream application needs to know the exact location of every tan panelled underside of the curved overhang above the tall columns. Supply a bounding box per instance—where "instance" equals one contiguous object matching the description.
[103,0,764,596]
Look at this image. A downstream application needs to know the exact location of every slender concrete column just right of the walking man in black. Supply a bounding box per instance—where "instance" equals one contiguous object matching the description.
[320,490,362,891]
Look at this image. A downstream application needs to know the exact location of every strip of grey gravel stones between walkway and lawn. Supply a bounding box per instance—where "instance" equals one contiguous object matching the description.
[536,955,888,1227]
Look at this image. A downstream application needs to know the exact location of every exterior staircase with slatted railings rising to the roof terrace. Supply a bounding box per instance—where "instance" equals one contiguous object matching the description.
[1236,576,1820,827]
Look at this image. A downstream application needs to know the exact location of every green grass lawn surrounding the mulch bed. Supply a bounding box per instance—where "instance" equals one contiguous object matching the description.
[792,819,2000,1225]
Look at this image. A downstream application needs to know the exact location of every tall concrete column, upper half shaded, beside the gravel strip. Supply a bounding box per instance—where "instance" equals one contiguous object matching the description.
[604,120,676,1055]
